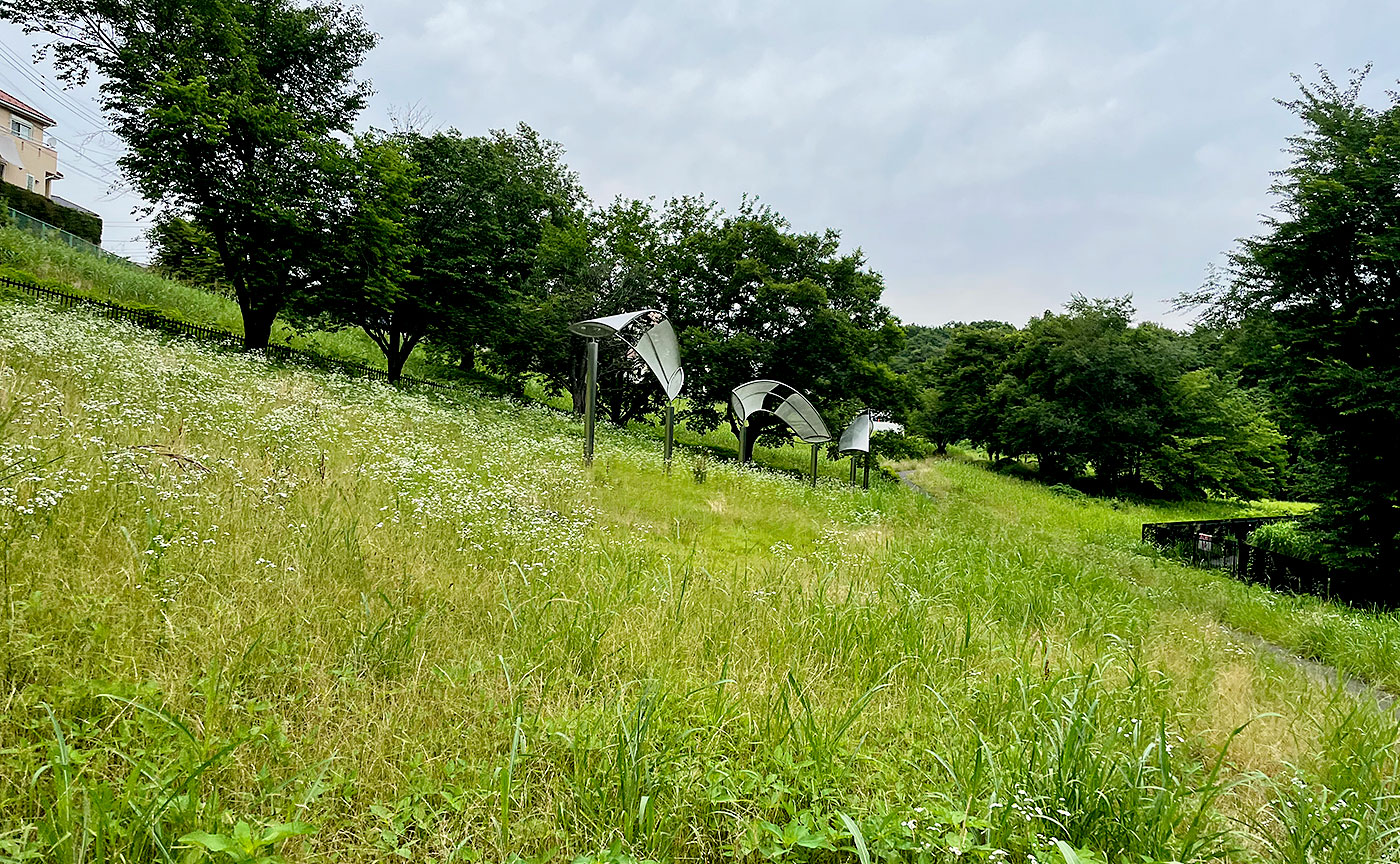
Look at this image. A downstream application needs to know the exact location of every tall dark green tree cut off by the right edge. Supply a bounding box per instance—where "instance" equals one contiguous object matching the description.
[1187,71,1400,576]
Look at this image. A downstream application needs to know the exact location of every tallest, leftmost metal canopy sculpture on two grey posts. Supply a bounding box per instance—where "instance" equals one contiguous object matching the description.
[568,309,686,466]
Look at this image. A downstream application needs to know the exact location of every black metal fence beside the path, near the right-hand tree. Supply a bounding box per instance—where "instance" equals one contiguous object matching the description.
[1142,517,1366,604]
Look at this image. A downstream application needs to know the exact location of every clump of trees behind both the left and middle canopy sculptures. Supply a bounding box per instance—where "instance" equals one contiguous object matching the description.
[517,197,911,441]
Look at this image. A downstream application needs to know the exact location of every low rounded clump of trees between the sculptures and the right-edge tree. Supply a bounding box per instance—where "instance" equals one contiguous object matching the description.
[910,297,1285,499]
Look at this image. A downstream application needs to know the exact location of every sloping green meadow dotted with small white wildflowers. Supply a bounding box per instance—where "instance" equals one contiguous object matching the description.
[0,267,1400,864]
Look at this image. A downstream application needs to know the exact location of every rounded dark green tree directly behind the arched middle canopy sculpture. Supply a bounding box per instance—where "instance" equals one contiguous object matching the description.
[664,200,913,450]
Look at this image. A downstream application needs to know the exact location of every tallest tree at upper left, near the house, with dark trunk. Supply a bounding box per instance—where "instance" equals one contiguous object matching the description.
[0,0,375,347]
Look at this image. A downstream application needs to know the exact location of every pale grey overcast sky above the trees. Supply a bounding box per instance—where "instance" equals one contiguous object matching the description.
[0,0,1400,326]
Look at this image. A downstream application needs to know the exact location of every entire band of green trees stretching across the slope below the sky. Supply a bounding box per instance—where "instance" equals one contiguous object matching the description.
[0,0,1400,569]
